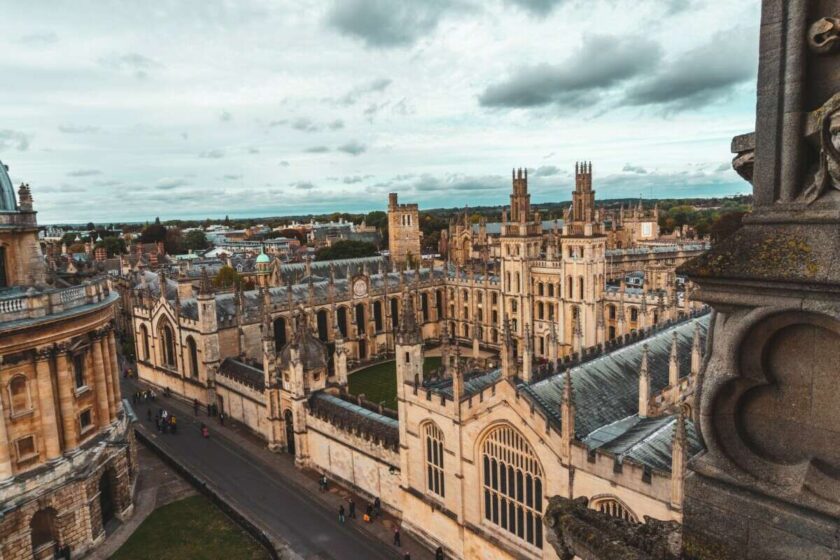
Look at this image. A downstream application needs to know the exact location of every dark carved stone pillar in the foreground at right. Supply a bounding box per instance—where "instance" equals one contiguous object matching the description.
[683,0,840,560]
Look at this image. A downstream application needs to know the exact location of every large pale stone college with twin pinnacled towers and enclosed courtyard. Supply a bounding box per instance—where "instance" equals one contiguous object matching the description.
[123,164,708,558]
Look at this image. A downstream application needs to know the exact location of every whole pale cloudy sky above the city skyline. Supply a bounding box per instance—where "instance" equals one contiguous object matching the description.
[0,0,759,223]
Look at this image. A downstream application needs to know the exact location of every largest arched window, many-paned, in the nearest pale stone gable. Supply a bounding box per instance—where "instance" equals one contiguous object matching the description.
[481,426,543,548]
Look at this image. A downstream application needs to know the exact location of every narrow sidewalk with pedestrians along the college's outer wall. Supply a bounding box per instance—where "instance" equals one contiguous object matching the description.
[122,379,434,560]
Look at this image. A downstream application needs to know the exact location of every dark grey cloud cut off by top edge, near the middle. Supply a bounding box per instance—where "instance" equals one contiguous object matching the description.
[327,0,455,48]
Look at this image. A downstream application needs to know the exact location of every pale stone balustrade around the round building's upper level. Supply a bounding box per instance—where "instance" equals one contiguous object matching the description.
[0,278,116,330]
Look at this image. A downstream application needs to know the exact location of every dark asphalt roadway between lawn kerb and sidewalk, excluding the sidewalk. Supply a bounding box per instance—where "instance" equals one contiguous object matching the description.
[123,381,410,560]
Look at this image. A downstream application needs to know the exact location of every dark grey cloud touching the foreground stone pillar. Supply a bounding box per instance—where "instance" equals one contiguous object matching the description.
[625,27,758,111]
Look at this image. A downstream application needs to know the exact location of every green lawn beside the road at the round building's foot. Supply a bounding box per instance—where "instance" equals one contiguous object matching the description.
[111,495,269,560]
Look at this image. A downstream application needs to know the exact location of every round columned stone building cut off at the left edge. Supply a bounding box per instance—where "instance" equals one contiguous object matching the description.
[0,163,137,560]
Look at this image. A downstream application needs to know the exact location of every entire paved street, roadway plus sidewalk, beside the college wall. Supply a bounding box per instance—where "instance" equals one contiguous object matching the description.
[122,379,434,560]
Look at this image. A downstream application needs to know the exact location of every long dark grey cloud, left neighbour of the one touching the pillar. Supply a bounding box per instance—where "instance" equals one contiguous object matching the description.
[479,35,662,108]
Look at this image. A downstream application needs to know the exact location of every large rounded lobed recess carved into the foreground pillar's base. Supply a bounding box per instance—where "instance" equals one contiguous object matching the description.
[707,311,840,514]
